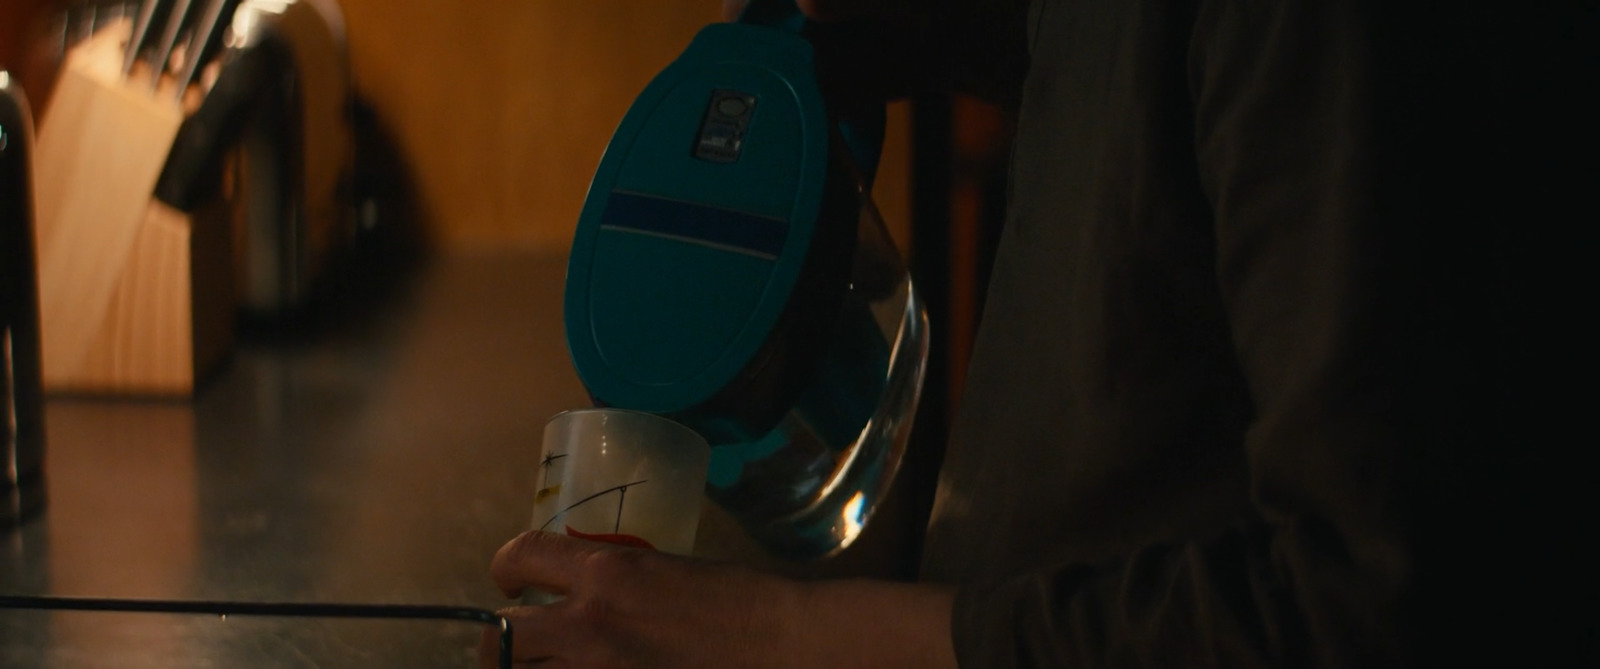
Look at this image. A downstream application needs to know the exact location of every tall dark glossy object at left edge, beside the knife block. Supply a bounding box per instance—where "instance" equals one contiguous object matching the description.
[0,70,45,528]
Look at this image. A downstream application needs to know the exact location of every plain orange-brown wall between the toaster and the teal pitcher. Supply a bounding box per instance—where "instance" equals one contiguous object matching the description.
[342,0,909,250]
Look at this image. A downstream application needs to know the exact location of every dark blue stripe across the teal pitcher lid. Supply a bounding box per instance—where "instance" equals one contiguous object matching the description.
[600,190,789,259]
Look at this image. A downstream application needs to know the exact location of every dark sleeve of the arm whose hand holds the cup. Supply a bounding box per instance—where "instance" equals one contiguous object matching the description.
[954,2,1594,667]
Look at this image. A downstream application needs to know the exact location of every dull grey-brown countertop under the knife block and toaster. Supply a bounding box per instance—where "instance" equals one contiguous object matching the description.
[0,251,915,667]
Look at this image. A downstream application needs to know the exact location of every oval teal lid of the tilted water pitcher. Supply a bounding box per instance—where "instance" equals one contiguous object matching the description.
[565,24,832,413]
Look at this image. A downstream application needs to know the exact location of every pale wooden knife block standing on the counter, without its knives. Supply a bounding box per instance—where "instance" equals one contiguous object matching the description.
[34,22,234,395]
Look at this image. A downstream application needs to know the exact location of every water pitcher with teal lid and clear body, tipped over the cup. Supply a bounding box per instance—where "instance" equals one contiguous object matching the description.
[563,0,928,560]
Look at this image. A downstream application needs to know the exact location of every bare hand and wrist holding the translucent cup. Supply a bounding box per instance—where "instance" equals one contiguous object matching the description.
[480,531,955,667]
